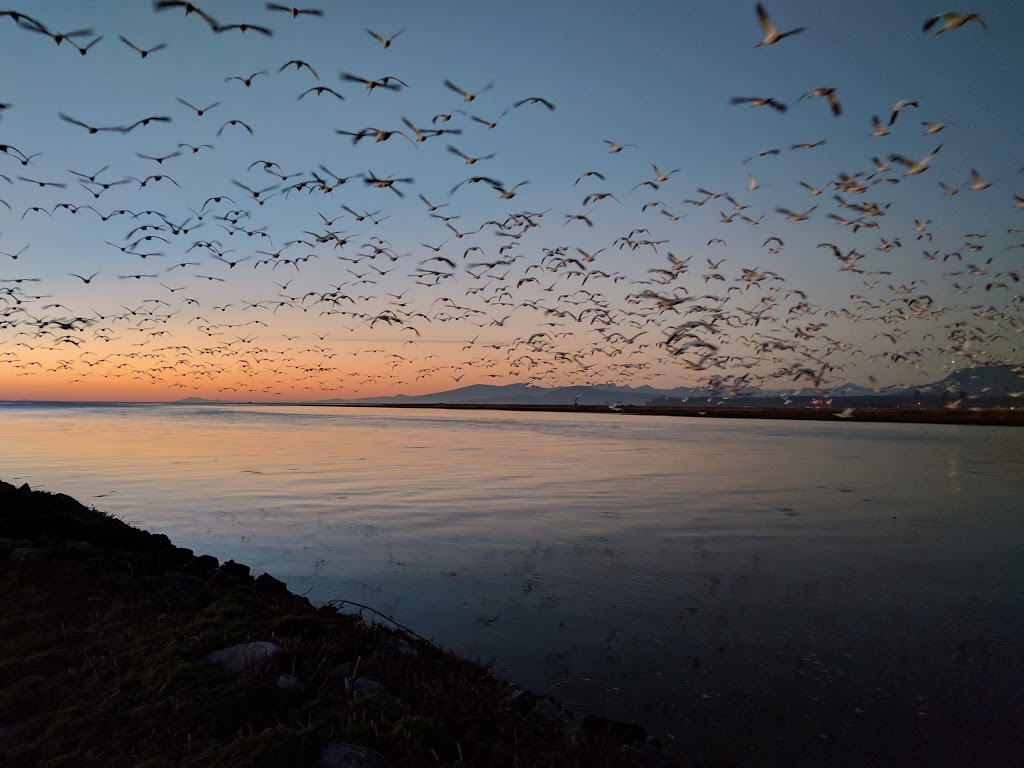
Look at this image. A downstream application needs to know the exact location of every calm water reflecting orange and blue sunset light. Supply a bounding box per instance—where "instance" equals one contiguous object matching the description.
[0,406,1024,765]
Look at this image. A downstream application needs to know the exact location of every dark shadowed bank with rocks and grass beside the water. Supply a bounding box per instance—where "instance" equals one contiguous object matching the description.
[0,482,671,768]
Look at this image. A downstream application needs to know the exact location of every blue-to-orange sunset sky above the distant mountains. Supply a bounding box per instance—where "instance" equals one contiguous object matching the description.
[0,0,1024,400]
